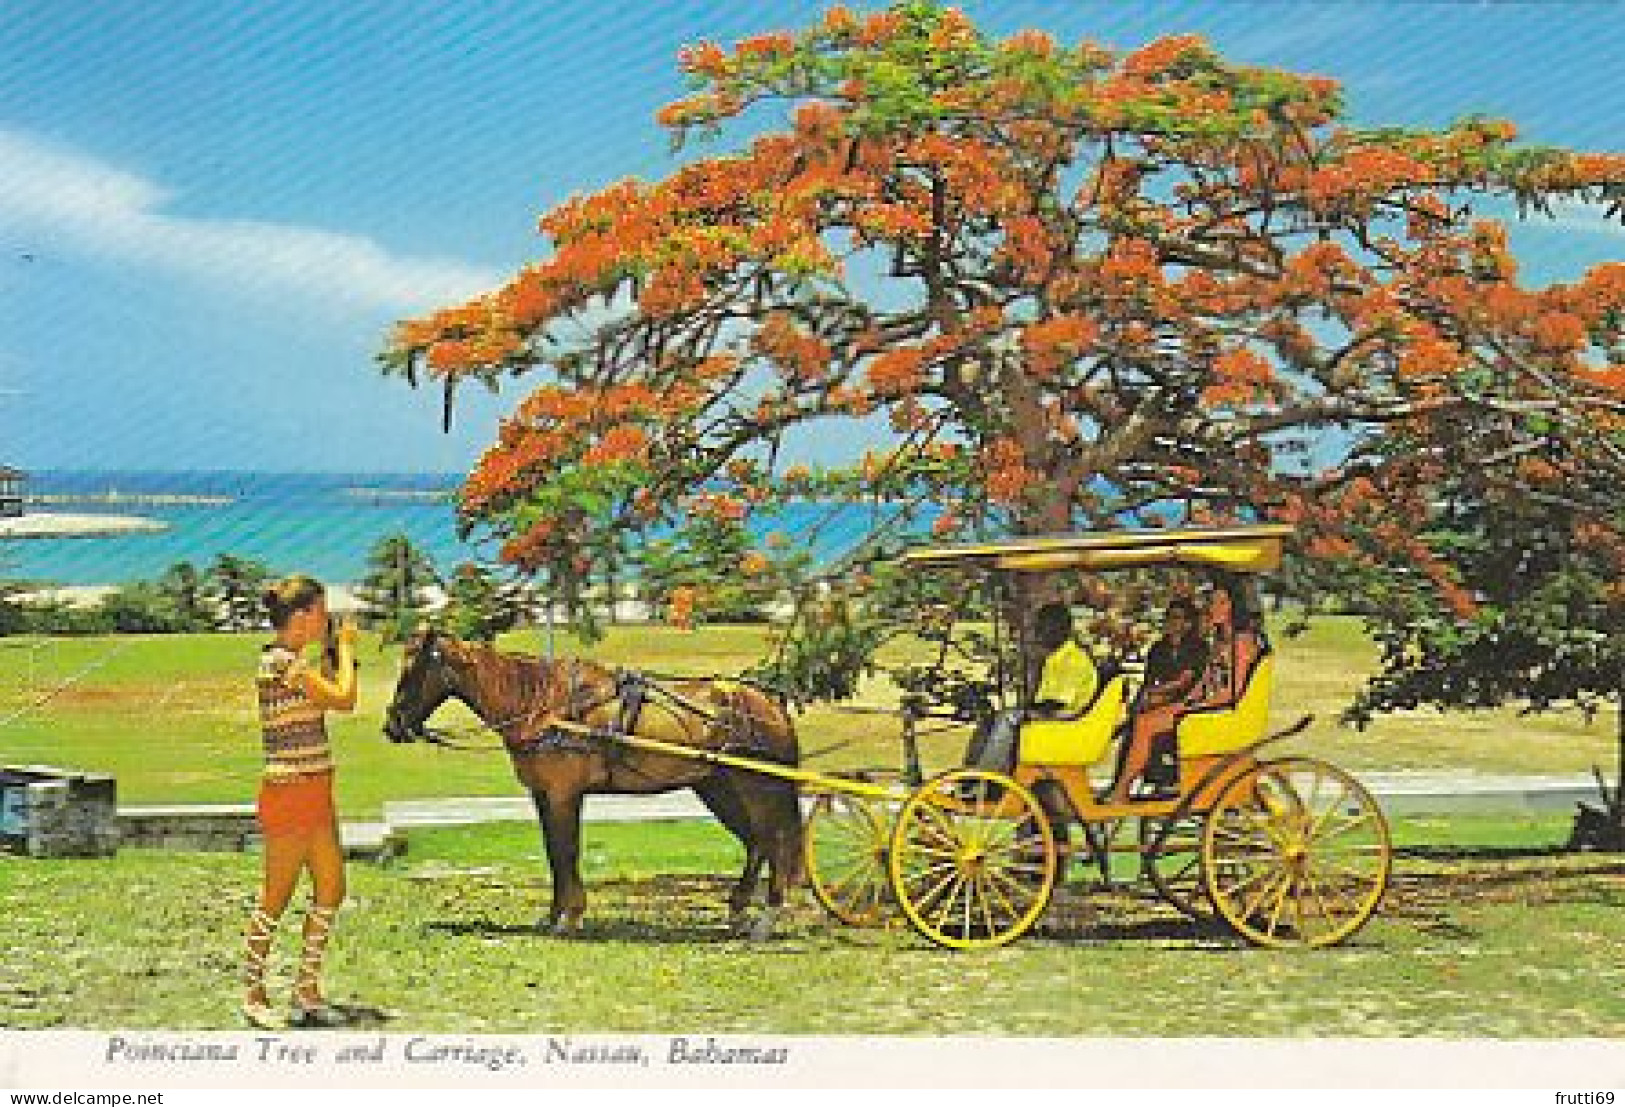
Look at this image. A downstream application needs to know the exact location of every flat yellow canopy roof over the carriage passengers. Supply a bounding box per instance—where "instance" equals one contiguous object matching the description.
[900,523,1294,572]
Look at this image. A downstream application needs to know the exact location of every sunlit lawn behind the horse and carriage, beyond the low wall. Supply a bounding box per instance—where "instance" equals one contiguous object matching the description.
[0,618,1615,818]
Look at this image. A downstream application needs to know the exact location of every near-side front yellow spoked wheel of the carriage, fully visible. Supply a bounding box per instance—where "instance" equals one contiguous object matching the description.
[891,769,1060,949]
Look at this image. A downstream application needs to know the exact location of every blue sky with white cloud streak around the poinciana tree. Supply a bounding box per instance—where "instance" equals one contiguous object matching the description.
[0,0,1625,471]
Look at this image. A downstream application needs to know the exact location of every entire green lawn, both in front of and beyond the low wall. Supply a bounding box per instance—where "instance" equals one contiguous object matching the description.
[0,619,1625,1037]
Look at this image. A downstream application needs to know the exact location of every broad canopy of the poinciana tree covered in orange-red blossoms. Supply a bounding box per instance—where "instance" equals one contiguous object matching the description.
[385,3,1625,682]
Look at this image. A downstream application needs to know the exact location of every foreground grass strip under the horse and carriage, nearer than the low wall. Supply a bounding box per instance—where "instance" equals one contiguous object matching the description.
[0,819,1625,1039]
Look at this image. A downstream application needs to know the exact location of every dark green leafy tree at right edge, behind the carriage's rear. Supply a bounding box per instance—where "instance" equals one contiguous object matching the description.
[1328,393,1625,849]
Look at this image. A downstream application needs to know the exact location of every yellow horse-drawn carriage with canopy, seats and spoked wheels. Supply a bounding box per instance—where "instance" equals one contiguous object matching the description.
[806,525,1391,948]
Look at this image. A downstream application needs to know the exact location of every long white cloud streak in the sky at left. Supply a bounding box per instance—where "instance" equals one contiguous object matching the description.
[0,128,502,312]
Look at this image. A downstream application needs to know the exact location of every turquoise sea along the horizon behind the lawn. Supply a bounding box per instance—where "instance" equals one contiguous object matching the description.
[0,470,897,585]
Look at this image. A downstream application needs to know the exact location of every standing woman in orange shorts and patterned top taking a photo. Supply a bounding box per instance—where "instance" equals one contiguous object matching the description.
[242,575,358,1029]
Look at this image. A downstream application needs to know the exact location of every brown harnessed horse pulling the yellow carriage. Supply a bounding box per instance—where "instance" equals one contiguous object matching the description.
[384,627,803,940]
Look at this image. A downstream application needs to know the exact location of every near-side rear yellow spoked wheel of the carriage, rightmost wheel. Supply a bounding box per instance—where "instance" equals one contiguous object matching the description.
[1203,758,1393,946]
